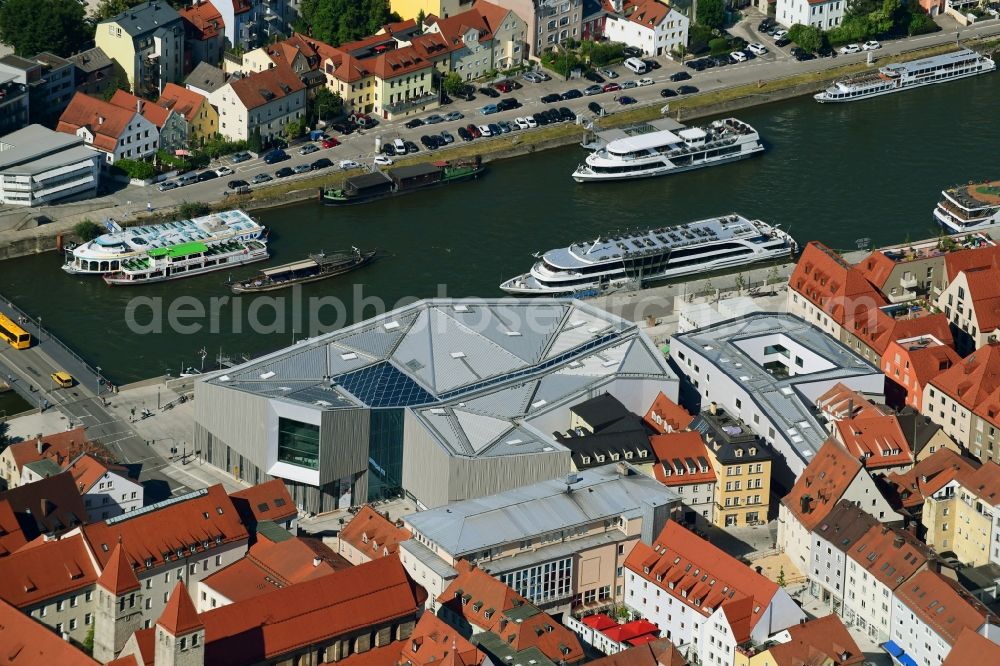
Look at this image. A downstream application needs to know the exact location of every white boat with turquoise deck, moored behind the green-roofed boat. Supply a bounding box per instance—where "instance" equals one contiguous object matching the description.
[63,210,264,275]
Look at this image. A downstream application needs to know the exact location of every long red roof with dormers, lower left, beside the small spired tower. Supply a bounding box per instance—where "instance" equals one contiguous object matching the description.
[83,485,249,571]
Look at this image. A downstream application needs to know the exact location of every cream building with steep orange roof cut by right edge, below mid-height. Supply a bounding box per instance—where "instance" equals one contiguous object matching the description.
[923,343,1000,452]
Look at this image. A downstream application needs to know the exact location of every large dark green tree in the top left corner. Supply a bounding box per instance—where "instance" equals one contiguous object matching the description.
[0,0,94,57]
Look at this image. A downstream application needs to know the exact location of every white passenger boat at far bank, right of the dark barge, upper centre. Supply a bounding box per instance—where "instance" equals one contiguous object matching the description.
[573,118,764,183]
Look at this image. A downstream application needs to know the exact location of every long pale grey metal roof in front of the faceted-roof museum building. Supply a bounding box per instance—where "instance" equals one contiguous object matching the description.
[403,464,679,559]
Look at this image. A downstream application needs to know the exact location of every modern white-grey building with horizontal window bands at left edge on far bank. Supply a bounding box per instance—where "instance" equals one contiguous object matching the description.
[0,125,101,205]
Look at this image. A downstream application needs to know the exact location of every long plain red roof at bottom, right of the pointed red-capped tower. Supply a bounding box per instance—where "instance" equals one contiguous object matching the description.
[201,557,426,666]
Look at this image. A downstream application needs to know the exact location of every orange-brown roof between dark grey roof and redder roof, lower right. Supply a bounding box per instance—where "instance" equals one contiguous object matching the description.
[847,525,933,590]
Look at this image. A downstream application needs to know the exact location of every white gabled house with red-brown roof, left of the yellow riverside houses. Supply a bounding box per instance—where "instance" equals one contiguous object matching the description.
[208,61,306,144]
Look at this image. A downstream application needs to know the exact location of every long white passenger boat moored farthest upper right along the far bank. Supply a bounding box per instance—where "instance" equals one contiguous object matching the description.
[813,49,996,102]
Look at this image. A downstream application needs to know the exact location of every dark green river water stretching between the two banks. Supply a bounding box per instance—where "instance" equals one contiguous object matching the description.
[0,74,1000,383]
